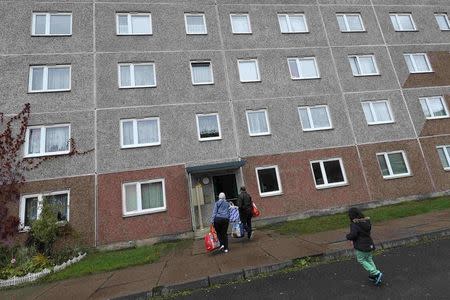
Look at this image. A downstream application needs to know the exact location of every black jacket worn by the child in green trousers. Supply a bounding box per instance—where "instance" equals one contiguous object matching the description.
[347,218,375,252]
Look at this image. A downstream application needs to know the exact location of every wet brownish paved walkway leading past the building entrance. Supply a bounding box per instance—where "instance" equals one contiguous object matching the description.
[0,210,450,299]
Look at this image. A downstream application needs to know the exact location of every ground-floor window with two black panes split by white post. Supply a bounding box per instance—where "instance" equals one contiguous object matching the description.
[311,158,347,189]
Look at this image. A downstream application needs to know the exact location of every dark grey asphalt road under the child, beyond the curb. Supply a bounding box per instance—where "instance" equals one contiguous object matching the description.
[178,239,450,300]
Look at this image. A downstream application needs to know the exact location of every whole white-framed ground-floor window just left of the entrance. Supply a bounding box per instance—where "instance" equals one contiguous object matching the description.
[122,179,166,216]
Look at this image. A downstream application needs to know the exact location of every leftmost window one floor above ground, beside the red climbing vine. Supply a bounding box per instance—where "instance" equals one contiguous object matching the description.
[25,124,70,157]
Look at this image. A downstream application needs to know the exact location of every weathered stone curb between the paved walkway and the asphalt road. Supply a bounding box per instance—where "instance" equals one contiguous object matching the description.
[112,229,450,300]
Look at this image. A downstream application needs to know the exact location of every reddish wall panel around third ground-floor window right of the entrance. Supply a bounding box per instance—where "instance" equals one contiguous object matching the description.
[359,140,433,200]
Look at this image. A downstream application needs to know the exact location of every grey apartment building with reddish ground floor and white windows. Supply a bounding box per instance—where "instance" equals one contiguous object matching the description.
[0,0,450,246]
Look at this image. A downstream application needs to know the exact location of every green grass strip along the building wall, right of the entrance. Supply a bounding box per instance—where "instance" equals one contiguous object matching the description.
[262,197,450,235]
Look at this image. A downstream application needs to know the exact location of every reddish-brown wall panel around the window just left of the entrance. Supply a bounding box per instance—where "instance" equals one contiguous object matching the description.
[98,166,192,244]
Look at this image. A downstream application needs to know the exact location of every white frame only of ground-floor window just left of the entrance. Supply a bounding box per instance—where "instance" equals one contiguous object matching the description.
[122,178,167,217]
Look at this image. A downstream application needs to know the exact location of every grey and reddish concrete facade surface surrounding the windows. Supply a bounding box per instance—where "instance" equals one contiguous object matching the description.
[0,0,450,245]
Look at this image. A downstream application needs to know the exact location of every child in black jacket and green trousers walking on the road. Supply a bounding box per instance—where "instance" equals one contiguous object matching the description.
[347,207,383,285]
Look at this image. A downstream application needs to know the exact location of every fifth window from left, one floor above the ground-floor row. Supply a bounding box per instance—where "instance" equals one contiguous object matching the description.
[298,105,332,131]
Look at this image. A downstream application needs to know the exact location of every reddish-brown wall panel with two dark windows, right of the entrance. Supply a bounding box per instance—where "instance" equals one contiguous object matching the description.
[243,147,370,217]
